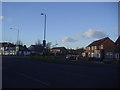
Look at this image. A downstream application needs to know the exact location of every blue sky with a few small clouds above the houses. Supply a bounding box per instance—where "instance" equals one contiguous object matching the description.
[0,2,118,48]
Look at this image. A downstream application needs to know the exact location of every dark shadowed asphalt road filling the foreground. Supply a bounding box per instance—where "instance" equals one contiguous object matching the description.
[2,57,119,89]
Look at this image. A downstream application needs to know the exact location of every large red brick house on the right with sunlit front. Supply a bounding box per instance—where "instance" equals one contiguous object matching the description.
[83,37,115,59]
